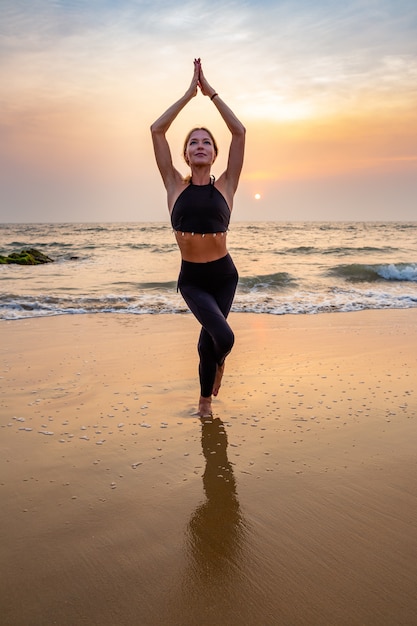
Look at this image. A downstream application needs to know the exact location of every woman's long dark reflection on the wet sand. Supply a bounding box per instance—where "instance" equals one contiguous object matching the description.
[162,418,252,626]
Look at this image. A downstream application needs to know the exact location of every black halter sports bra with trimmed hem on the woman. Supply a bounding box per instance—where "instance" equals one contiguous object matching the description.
[171,181,230,235]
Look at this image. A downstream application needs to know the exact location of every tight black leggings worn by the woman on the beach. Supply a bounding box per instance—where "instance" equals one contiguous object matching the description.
[178,254,238,398]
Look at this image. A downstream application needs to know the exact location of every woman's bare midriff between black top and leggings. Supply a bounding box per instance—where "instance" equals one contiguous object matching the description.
[175,231,227,263]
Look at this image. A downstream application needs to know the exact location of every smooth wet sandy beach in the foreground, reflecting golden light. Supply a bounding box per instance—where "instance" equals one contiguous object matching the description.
[0,309,417,626]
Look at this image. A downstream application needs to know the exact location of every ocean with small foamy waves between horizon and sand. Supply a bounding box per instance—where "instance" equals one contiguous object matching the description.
[0,222,417,320]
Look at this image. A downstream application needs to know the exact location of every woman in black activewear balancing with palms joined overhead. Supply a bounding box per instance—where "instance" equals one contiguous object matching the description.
[151,59,245,417]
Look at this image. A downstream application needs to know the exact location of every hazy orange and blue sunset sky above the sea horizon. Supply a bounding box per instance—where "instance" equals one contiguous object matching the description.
[0,0,417,222]
